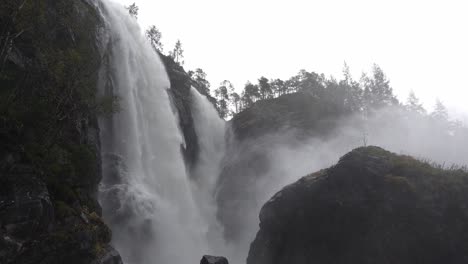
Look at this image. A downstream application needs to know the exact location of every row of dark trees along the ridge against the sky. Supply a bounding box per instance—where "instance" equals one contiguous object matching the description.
[126,3,458,127]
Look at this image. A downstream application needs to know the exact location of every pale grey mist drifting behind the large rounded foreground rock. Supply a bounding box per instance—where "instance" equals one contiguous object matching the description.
[218,104,468,263]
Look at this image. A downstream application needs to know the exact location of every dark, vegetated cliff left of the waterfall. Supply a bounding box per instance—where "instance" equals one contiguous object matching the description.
[0,0,121,264]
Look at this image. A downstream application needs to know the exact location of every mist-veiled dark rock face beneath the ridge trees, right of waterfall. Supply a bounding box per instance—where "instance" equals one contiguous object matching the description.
[217,93,344,240]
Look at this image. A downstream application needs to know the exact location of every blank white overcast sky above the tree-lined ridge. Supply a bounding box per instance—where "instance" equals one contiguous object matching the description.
[114,0,468,116]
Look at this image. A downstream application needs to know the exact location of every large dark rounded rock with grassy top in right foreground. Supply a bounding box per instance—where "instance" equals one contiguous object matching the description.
[247,147,468,264]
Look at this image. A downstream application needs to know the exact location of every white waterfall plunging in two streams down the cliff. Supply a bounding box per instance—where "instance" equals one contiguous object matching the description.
[100,1,228,264]
